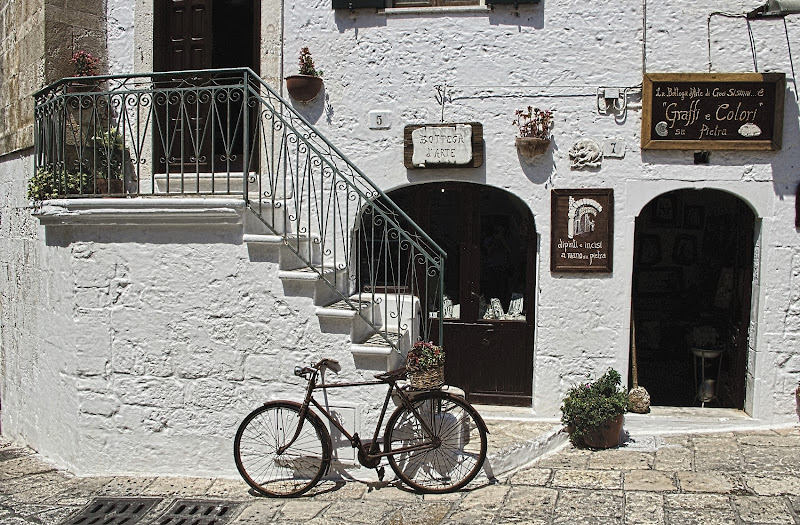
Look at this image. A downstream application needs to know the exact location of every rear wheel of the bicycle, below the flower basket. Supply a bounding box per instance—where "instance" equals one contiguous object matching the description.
[384,391,486,493]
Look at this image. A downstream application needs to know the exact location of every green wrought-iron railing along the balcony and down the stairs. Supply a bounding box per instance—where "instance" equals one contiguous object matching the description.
[30,69,445,353]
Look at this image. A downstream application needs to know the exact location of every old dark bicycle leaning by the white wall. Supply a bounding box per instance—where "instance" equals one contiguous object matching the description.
[233,359,488,497]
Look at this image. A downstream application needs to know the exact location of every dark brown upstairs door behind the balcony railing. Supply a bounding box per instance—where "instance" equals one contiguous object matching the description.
[153,0,260,173]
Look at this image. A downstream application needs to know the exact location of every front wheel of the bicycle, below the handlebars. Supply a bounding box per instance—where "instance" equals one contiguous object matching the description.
[233,401,331,496]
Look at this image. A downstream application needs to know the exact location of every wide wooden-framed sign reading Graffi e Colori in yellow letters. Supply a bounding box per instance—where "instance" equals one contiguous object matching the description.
[642,73,786,150]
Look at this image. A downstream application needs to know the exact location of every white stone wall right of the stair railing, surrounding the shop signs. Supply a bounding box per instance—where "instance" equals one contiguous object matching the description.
[284,1,800,421]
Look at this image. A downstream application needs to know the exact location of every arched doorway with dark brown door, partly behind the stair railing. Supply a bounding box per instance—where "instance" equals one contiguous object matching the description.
[374,182,536,406]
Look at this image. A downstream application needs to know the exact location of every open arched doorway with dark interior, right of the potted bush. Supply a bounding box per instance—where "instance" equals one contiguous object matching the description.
[631,189,755,410]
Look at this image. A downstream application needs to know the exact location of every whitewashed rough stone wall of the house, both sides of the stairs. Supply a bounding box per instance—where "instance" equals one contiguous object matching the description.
[0,0,800,475]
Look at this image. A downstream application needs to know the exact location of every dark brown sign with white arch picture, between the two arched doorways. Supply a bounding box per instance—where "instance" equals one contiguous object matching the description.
[550,189,614,272]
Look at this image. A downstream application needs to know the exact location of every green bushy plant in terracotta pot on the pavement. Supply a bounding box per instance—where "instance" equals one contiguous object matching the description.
[561,368,628,448]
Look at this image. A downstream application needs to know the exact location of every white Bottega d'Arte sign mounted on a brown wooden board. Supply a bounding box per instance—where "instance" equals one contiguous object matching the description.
[403,122,483,169]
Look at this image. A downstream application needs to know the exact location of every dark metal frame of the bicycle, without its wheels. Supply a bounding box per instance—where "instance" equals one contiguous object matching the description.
[278,369,439,466]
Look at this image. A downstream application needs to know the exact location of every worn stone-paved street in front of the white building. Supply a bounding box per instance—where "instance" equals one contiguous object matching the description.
[0,427,800,525]
